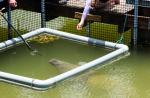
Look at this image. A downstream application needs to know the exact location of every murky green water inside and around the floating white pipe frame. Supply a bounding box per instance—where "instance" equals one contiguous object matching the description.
[0,40,150,98]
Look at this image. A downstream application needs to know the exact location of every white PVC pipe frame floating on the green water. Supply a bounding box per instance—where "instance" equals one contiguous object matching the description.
[0,28,129,90]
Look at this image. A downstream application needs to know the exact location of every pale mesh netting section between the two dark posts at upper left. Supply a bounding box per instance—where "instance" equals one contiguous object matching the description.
[12,9,41,35]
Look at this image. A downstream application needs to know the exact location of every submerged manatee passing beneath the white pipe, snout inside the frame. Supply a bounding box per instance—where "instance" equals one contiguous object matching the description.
[49,59,117,90]
